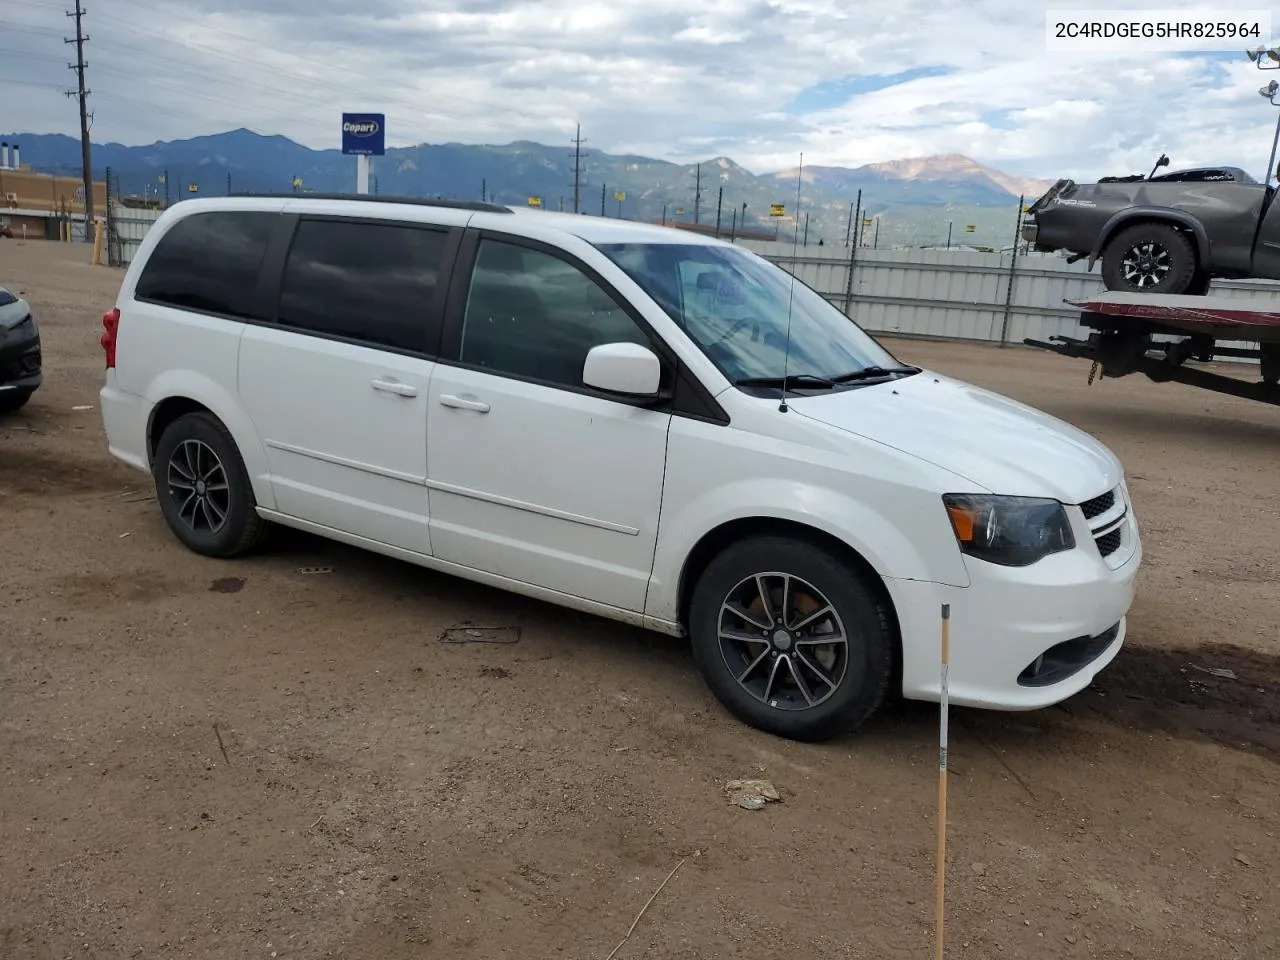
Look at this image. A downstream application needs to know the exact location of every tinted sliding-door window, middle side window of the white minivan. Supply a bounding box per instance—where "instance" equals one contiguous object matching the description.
[279,220,448,352]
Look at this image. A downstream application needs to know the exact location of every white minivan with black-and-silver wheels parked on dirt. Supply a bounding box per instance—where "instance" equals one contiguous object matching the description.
[94,195,1142,740]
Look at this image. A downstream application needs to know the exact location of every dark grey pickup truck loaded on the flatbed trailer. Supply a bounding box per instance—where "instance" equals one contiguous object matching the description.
[1023,165,1280,294]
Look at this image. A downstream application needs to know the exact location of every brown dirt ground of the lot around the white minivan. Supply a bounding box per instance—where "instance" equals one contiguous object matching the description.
[0,241,1280,960]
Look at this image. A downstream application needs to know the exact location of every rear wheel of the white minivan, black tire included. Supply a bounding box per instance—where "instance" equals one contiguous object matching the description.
[151,412,266,558]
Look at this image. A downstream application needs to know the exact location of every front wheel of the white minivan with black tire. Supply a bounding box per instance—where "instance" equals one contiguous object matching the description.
[689,536,895,741]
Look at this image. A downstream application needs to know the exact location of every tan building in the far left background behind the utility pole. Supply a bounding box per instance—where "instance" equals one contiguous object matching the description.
[0,143,106,241]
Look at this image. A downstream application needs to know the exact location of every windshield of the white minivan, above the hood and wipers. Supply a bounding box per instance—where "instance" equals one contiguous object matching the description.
[598,243,900,389]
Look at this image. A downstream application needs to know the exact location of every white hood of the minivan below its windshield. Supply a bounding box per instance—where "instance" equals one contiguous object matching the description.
[787,370,1124,503]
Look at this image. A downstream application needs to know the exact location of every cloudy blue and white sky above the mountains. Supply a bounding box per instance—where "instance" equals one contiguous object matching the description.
[0,0,1280,178]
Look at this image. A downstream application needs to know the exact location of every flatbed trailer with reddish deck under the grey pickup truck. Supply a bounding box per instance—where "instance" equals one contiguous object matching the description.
[1023,291,1280,406]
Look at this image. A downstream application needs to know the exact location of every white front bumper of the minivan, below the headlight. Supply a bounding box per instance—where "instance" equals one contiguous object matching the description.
[886,497,1142,710]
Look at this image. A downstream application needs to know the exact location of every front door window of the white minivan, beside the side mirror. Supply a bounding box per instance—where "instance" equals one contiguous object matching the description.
[461,239,650,387]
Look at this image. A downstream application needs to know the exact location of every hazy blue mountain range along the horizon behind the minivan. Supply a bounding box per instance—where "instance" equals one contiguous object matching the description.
[0,128,1051,246]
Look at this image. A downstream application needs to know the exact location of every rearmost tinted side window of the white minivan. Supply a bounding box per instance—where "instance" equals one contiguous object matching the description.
[134,211,279,317]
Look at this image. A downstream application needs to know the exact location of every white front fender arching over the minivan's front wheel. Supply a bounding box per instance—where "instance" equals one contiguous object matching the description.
[645,477,969,621]
